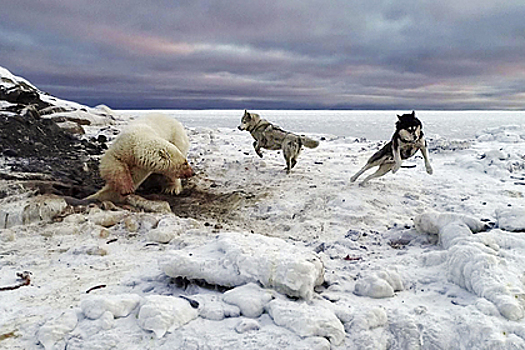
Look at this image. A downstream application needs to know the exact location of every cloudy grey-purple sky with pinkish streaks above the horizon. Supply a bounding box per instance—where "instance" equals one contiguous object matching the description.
[0,0,525,110]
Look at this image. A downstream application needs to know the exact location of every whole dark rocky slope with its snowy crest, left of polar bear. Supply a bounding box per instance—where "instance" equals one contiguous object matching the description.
[0,67,113,198]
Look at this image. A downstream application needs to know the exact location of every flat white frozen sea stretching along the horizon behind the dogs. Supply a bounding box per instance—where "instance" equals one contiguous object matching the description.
[120,110,525,140]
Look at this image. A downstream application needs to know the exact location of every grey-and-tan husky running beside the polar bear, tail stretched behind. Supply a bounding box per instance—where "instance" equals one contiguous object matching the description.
[237,110,319,173]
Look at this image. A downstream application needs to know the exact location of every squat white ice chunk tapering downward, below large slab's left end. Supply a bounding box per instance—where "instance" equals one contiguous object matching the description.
[138,295,198,338]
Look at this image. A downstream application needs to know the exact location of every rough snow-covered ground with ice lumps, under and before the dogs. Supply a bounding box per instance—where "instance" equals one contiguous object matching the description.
[0,111,525,350]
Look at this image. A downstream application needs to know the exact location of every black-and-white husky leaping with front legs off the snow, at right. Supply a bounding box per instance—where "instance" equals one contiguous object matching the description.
[350,111,432,184]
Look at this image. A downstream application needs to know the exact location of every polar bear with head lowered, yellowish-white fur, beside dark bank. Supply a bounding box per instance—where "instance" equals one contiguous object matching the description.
[86,113,193,202]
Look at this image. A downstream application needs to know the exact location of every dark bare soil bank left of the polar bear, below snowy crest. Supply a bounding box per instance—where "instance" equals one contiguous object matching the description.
[0,112,107,197]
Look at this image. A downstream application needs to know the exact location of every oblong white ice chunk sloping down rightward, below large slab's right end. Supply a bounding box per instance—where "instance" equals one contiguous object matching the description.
[267,299,345,345]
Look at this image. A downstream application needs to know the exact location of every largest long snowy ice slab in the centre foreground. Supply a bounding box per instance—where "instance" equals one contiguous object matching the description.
[160,233,324,299]
